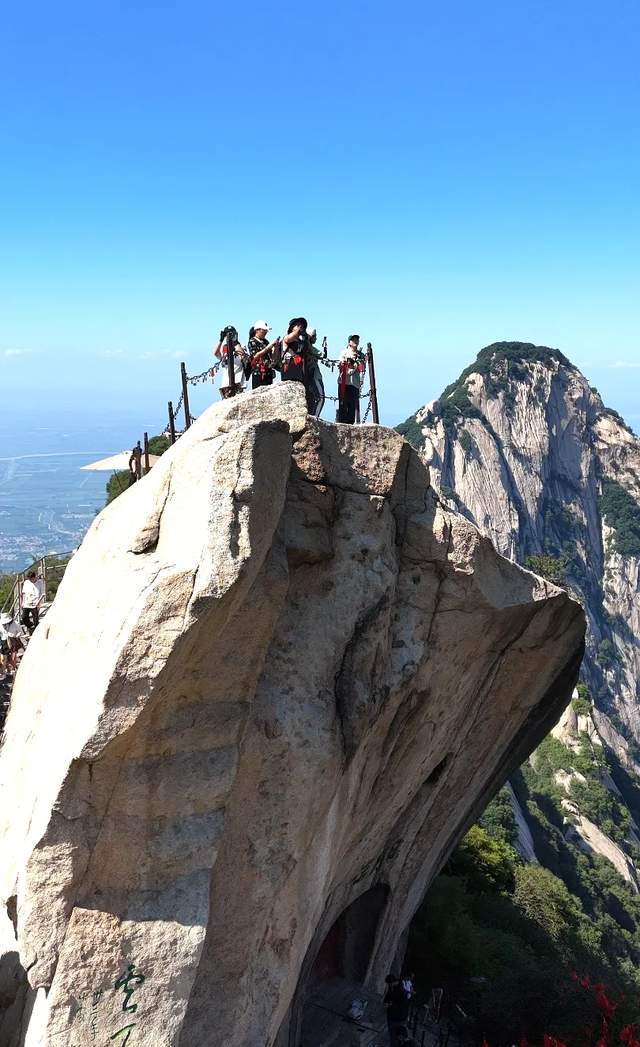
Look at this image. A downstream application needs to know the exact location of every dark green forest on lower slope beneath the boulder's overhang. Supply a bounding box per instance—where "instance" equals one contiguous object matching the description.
[407,762,640,1047]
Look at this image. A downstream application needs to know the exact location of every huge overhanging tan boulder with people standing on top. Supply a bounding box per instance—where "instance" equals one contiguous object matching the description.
[0,383,584,1047]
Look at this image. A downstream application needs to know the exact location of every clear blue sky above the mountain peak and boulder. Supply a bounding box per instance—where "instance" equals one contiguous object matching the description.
[0,0,640,429]
